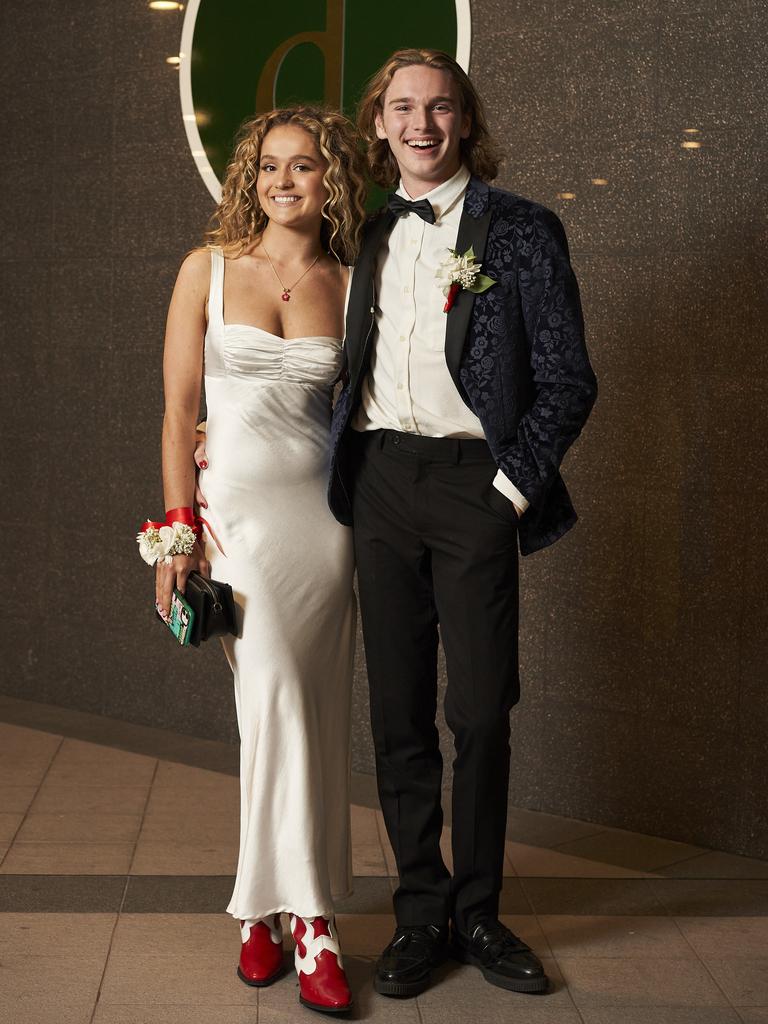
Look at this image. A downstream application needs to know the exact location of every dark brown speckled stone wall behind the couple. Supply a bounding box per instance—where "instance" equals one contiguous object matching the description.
[0,0,768,856]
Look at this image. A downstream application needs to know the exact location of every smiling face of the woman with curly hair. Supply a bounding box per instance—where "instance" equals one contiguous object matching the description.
[256,124,328,227]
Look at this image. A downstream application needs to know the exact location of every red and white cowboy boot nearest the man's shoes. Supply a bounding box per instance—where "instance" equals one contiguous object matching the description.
[291,914,352,1014]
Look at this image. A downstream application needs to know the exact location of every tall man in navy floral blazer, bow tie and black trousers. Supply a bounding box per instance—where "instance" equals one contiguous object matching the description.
[330,50,596,996]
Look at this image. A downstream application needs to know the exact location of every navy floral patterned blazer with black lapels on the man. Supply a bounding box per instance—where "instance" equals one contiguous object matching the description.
[329,177,597,555]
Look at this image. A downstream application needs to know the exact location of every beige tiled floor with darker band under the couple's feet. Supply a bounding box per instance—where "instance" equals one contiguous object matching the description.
[0,700,768,1024]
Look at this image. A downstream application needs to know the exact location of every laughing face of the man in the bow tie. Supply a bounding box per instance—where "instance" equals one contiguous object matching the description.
[376,65,471,199]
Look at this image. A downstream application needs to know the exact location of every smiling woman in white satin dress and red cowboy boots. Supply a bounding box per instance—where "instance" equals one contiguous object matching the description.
[157,108,365,1013]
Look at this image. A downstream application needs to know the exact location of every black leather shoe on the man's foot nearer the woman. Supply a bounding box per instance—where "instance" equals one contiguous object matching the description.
[374,925,449,998]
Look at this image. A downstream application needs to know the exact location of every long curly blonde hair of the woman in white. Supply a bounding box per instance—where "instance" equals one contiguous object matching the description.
[206,106,366,264]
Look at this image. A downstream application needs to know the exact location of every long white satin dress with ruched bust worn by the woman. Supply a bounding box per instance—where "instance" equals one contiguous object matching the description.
[201,249,355,921]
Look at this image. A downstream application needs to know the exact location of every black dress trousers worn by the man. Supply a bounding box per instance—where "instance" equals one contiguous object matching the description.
[349,430,519,934]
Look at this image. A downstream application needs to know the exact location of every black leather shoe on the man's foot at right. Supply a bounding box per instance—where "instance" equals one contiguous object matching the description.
[451,921,549,992]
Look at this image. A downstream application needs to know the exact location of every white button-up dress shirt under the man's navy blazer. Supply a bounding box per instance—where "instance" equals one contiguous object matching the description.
[352,167,528,520]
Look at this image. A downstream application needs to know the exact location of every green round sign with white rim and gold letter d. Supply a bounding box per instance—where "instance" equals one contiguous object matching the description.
[179,0,471,202]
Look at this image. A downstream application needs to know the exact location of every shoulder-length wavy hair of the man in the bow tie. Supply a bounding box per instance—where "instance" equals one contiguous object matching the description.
[357,49,501,188]
